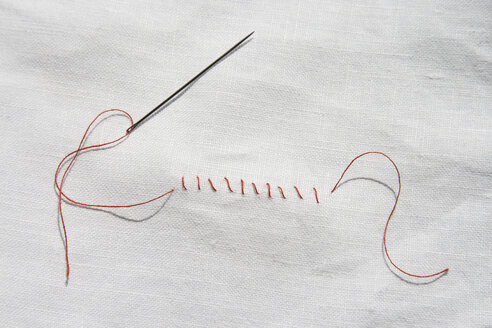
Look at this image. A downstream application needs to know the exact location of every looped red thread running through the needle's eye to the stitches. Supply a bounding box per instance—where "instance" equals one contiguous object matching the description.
[55,109,174,282]
